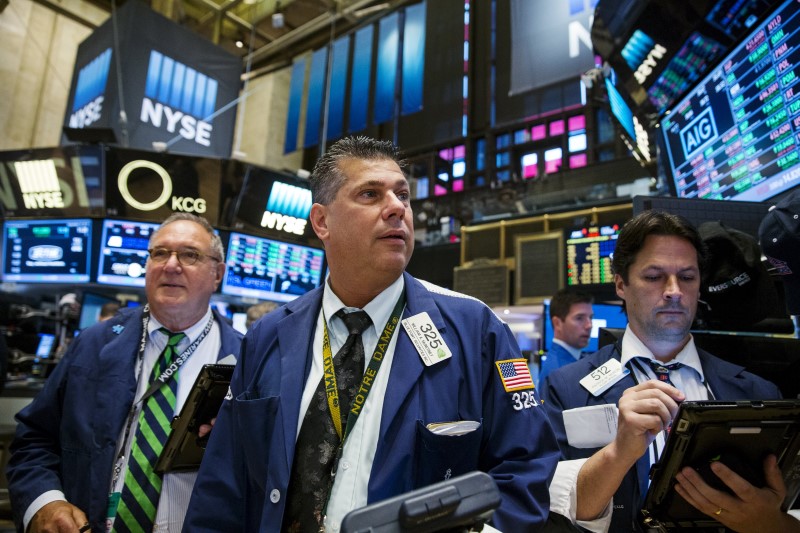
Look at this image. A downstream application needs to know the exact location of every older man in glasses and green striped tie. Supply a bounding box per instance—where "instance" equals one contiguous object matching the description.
[7,213,241,533]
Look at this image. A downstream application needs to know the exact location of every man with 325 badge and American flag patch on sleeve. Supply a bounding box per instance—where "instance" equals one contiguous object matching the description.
[184,137,559,533]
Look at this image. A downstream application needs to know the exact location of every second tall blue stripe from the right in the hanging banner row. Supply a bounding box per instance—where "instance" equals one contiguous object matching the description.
[373,13,400,124]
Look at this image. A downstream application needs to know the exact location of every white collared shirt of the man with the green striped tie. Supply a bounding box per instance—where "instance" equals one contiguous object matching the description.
[23,308,222,532]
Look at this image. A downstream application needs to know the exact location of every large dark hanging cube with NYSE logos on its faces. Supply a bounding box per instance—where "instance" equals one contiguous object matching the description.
[64,1,242,157]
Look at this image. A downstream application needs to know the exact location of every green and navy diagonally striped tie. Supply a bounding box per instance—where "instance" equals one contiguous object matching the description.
[114,328,186,533]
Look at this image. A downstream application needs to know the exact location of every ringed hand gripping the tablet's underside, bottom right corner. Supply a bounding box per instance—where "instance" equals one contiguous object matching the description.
[675,455,800,533]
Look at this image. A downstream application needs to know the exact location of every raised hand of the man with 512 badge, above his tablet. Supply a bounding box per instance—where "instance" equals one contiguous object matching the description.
[613,380,686,466]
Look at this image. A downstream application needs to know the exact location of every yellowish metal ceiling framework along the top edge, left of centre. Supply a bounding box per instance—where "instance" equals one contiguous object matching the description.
[43,0,418,77]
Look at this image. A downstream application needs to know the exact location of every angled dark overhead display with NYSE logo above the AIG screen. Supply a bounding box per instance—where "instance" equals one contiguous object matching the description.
[592,0,779,120]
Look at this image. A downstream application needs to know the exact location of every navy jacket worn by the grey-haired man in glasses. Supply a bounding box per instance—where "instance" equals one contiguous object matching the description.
[7,307,242,531]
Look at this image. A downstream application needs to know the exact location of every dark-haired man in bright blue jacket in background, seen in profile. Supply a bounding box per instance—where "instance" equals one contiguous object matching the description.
[539,289,594,383]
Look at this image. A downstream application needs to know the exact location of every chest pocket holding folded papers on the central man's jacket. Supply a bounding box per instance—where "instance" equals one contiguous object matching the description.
[416,420,483,487]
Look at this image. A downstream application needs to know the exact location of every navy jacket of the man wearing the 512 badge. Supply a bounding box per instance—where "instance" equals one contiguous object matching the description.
[542,341,780,533]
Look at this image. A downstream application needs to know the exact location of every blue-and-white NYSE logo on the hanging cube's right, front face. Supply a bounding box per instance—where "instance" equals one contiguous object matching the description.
[139,50,218,146]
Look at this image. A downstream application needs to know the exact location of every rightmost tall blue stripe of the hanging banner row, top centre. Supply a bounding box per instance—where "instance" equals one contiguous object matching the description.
[401,2,426,115]
